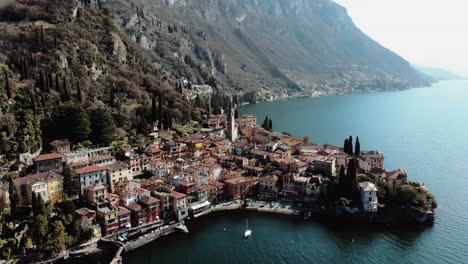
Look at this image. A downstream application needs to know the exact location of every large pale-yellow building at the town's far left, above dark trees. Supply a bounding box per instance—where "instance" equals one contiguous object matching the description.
[13,172,63,202]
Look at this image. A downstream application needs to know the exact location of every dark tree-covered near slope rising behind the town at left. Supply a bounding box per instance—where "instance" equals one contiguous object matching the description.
[0,0,200,166]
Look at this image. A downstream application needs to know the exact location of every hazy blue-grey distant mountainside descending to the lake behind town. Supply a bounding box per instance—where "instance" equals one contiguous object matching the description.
[106,0,427,99]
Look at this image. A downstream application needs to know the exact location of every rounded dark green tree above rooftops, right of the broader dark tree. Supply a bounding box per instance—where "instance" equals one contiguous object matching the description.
[89,108,116,145]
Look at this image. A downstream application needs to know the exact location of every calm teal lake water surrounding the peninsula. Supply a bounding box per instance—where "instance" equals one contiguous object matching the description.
[124,81,468,263]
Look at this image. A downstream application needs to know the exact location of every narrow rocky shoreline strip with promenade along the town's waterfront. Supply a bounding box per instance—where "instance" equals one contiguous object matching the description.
[59,200,434,264]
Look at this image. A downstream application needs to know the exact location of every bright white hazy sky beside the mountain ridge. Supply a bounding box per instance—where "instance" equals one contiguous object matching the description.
[333,0,468,76]
